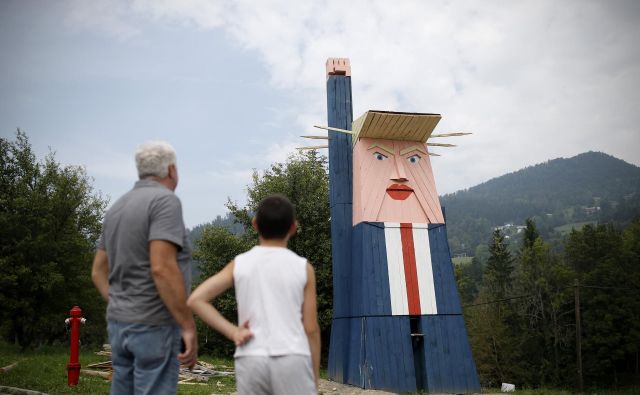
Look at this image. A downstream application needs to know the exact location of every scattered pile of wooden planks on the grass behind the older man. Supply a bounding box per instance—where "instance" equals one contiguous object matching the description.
[80,344,235,385]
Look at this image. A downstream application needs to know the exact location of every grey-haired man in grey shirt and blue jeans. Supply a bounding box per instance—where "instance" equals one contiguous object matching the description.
[91,142,198,394]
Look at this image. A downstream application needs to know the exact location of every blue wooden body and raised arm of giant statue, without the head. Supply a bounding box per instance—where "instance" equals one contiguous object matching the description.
[327,59,480,393]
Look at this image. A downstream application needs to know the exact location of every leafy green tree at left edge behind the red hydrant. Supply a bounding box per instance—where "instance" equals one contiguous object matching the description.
[0,131,106,348]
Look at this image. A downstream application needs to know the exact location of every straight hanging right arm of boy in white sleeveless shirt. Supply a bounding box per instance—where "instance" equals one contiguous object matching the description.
[302,262,320,388]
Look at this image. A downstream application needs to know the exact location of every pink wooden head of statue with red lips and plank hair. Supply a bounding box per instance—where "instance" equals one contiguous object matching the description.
[353,111,444,226]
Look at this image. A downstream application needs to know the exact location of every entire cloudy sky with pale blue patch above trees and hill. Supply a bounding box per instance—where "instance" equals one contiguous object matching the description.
[0,0,640,227]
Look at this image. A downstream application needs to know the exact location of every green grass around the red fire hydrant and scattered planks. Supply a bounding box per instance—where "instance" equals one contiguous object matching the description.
[0,343,236,395]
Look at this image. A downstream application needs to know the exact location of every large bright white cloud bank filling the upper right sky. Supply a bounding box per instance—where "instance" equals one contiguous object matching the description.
[62,0,640,193]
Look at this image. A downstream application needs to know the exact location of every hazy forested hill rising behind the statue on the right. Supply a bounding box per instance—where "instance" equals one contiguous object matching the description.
[441,152,640,255]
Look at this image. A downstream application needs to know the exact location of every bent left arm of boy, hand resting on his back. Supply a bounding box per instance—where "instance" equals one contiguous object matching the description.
[187,261,253,346]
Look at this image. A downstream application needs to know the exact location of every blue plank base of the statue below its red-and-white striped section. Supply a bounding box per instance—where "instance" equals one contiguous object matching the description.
[336,315,480,393]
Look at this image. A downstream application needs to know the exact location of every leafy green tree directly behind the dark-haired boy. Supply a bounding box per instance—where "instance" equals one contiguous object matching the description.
[196,151,333,356]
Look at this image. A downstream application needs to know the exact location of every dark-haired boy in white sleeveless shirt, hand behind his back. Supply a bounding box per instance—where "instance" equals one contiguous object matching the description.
[188,195,320,395]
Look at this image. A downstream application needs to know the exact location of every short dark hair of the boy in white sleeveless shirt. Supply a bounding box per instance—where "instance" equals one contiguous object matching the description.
[256,195,296,239]
